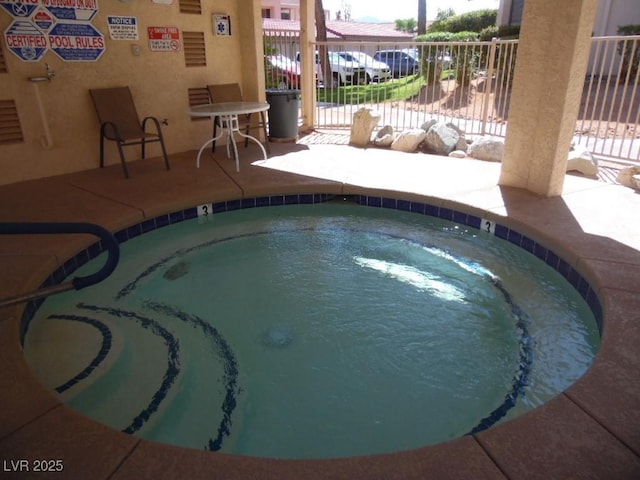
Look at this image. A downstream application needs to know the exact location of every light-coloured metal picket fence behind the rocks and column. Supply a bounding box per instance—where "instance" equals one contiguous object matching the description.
[265,31,640,162]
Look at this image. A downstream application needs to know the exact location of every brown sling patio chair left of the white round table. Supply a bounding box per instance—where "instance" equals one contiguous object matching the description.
[89,87,171,178]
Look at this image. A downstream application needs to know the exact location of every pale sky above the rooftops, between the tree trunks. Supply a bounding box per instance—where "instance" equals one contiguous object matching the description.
[322,0,499,22]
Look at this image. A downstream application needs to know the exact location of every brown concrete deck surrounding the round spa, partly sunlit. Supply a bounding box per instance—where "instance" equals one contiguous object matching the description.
[0,143,640,480]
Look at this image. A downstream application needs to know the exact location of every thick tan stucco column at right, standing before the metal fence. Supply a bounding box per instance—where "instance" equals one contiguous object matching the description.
[499,0,598,196]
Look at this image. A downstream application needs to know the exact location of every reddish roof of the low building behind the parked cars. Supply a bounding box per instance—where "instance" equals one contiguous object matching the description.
[262,18,414,41]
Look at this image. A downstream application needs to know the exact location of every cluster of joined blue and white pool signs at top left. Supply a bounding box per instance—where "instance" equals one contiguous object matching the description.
[0,0,105,62]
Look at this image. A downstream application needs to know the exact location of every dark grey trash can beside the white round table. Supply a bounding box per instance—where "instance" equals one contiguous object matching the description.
[267,89,300,141]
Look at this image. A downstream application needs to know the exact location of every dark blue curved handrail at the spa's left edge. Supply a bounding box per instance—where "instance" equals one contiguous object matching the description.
[0,222,120,308]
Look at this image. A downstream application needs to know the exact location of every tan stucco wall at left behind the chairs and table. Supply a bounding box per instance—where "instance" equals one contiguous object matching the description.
[0,0,264,184]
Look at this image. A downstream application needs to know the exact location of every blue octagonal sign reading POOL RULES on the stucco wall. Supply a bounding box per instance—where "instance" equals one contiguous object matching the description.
[49,23,105,62]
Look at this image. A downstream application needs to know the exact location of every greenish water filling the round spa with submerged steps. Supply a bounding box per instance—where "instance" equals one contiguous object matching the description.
[24,204,600,458]
